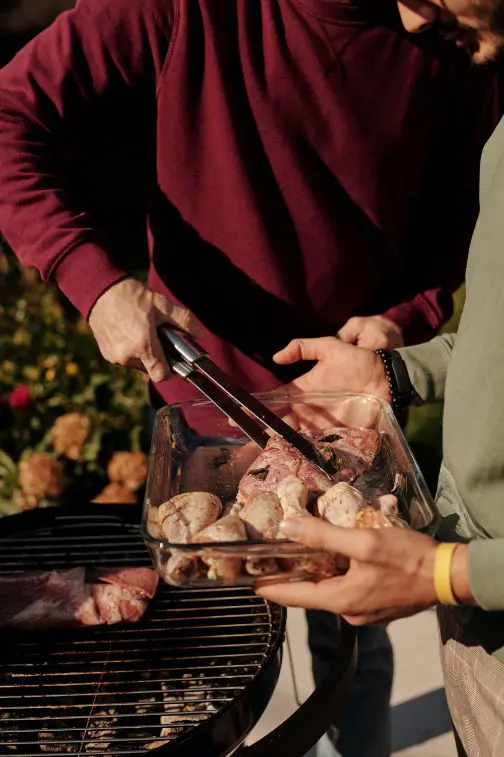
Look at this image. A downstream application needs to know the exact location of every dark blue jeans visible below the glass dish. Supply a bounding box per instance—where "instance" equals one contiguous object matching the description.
[306,610,394,757]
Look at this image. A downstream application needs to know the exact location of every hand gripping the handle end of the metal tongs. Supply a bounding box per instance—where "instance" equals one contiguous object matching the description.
[89,279,199,382]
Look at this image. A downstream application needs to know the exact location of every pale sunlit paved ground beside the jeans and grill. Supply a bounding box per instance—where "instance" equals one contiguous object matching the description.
[248,610,456,757]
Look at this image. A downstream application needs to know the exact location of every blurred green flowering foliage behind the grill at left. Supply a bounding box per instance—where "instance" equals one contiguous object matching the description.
[0,242,148,515]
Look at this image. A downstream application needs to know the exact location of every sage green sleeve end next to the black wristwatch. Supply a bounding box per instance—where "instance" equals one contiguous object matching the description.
[398,334,456,402]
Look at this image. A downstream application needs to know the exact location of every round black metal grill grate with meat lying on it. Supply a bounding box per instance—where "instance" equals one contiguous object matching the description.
[0,515,281,757]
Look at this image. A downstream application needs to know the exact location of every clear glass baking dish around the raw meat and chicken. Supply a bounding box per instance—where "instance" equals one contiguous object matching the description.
[142,393,436,588]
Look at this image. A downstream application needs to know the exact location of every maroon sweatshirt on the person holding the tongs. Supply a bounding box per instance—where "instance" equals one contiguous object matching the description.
[0,0,496,408]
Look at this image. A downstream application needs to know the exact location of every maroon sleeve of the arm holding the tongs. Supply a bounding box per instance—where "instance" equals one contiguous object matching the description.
[0,0,176,317]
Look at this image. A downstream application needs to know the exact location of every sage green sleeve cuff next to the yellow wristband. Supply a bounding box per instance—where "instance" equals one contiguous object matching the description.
[469,539,504,611]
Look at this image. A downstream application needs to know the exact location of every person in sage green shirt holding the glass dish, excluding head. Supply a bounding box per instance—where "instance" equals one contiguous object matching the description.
[258,113,504,757]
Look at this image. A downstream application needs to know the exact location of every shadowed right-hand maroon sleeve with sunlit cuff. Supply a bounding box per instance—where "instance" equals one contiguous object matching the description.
[383,70,499,345]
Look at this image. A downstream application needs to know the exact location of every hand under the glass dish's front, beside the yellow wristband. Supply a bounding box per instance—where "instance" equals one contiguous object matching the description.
[256,518,448,626]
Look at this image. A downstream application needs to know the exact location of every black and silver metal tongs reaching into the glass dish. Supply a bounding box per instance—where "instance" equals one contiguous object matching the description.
[158,325,331,475]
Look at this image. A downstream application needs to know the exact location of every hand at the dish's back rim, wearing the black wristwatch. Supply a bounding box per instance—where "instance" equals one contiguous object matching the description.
[271,336,390,401]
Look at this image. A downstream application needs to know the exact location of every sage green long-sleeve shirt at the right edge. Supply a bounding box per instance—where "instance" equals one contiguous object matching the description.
[400,119,504,662]
